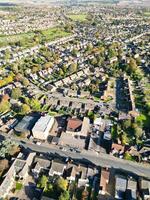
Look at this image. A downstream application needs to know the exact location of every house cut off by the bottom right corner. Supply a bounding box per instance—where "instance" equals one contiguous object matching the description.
[139,179,150,200]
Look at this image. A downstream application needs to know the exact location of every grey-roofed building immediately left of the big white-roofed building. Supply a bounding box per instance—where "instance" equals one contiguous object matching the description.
[14,115,37,134]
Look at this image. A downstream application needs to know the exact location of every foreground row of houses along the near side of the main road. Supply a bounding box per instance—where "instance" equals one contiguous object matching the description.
[0,153,150,200]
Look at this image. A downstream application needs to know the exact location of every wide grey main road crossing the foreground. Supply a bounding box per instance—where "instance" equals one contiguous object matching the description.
[2,133,150,178]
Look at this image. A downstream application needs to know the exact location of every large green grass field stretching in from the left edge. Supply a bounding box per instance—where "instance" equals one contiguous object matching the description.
[0,27,70,48]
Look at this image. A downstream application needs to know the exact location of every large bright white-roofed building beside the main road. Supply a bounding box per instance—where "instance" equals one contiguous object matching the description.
[32,115,55,140]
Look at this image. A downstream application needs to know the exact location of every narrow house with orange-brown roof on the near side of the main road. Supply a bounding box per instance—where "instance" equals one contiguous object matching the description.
[99,168,110,195]
